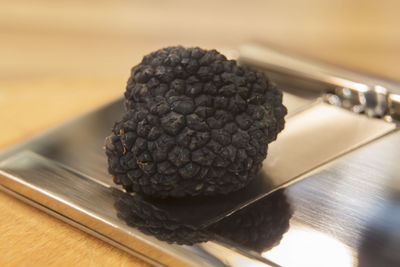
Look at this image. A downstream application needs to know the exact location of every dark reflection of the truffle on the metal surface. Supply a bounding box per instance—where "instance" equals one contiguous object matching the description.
[115,190,292,252]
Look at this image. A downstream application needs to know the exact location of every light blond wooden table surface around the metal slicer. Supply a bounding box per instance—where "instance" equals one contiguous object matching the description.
[0,0,400,266]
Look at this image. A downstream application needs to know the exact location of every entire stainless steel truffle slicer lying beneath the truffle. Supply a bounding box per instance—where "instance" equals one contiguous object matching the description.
[0,45,400,266]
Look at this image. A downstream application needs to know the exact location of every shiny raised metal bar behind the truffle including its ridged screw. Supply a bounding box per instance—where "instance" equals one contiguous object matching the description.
[238,44,400,121]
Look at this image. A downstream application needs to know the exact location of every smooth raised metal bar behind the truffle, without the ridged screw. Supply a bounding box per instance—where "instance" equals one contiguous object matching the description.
[237,44,400,94]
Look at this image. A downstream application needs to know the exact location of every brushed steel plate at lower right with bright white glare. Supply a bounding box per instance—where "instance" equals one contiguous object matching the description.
[262,132,400,266]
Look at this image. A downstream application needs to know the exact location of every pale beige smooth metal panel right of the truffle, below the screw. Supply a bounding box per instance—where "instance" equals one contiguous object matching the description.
[262,102,395,185]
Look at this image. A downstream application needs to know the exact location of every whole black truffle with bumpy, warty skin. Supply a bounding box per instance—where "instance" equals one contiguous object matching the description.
[106,46,287,197]
